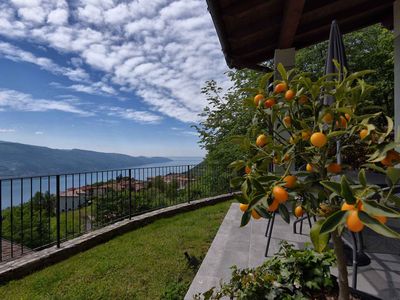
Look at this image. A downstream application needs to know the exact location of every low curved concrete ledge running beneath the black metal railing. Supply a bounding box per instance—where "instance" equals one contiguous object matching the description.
[0,193,234,284]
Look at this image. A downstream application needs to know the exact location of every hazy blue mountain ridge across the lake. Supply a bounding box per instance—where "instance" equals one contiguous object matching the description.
[0,141,171,178]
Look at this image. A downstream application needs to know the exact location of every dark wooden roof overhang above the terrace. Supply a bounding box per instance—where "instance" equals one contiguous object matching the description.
[207,0,394,70]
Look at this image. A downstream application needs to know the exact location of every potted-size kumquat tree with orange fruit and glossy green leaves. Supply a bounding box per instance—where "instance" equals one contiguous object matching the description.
[231,62,400,299]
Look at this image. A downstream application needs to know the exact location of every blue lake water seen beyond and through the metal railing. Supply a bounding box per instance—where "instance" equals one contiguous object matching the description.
[1,157,203,209]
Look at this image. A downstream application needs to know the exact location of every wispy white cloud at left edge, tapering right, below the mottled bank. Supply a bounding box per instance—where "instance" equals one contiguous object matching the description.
[0,89,93,116]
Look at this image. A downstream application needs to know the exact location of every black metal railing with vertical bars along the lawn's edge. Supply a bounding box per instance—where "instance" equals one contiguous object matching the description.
[0,164,230,261]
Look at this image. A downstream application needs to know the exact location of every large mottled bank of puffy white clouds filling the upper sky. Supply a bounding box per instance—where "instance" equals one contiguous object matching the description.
[0,0,229,122]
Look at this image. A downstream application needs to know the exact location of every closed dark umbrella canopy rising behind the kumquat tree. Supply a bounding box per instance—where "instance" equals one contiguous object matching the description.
[324,20,347,105]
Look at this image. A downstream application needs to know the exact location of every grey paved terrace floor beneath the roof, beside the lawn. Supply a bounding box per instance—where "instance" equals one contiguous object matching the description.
[185,203,400,299]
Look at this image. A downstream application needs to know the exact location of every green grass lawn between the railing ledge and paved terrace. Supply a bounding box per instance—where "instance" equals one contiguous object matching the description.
[0,201,231,299]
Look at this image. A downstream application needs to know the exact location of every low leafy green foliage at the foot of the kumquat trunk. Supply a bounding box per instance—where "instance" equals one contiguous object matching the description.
[195,242,335,300]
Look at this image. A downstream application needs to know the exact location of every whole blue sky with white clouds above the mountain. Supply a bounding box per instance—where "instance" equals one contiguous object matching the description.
[0,0,229,156]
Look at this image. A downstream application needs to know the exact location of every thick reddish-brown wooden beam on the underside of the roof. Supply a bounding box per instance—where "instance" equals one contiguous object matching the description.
[278,0,305,49]
